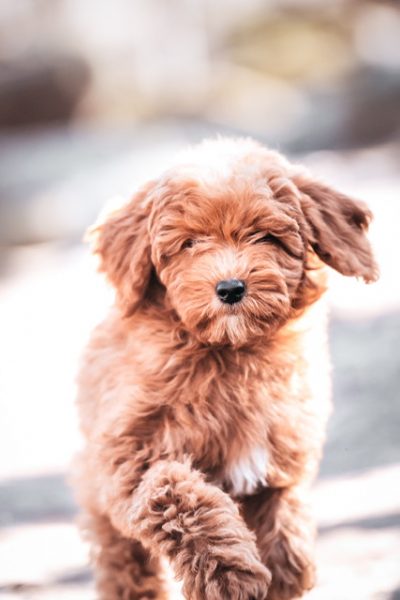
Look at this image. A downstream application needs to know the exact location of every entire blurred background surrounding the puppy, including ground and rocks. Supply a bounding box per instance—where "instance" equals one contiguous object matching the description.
[0,0,400,600]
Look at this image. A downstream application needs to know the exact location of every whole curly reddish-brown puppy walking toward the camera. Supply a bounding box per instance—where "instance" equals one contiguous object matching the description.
[78,139,377,600]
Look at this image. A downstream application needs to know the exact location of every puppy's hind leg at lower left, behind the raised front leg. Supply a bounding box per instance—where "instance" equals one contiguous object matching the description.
[81,514,167,600]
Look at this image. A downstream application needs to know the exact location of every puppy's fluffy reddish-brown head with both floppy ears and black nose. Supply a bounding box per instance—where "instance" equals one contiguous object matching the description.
[91,140,377,345]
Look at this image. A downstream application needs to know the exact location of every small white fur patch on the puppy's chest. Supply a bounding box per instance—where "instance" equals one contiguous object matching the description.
[224,446,268,496]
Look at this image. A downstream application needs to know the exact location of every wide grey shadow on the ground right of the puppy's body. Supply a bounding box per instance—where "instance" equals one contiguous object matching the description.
[320,312,400,477]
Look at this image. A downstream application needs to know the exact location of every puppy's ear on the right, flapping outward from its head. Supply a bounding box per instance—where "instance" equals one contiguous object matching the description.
[292,173,378,283]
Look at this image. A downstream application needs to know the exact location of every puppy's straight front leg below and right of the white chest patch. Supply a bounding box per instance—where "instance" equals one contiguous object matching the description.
[243,488,315,600]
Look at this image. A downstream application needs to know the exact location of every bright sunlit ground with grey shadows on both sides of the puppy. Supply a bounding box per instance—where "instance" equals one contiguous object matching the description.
[0,134,400,600]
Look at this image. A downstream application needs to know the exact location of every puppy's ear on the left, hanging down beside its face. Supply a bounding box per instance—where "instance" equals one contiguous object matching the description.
[88,182,154,316]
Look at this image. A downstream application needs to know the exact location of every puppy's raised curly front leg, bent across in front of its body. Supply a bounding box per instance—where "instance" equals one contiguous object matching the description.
[109,460,271,600]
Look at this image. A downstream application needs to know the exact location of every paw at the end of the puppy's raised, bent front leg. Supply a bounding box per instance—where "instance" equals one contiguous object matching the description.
[184,557,271,600]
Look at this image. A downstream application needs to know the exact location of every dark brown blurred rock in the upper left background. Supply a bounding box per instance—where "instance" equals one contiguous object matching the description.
[0,54,90,128]
